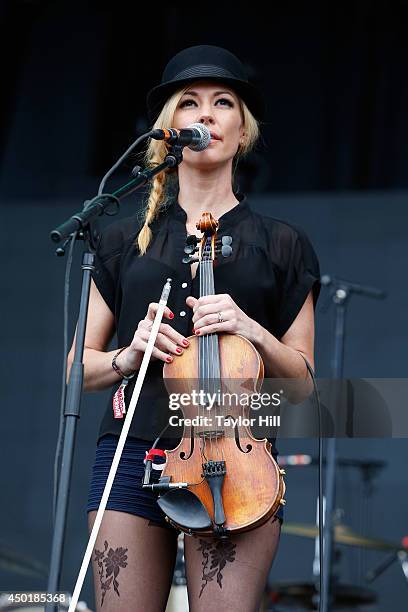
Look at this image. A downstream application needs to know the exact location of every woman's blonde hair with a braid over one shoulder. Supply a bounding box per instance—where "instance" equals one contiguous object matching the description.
[137,84,260,255]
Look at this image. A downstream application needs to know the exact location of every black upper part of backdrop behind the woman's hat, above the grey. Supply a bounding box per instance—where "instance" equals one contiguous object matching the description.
[0,0,408,197]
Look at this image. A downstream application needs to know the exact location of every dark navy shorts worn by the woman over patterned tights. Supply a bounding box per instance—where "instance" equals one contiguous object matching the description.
[87,434,283,533]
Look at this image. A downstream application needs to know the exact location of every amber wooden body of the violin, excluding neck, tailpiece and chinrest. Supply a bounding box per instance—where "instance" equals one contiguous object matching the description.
[162,334,285,535]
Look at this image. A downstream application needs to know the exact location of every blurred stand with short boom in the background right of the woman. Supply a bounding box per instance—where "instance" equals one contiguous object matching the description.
[320,275,386,612]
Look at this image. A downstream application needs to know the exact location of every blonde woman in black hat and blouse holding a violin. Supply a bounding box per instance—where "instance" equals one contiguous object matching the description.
[70,45,319,612]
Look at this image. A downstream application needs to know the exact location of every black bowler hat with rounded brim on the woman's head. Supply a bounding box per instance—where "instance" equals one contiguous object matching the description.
[147,45,264,121]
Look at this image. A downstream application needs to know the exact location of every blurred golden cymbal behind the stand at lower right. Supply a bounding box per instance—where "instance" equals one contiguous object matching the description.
[282,522,406,551]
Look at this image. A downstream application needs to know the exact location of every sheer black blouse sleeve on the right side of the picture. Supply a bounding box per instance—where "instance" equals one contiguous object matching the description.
[276,226,321,338]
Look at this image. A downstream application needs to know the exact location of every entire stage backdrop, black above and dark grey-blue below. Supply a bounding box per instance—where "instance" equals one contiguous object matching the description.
[0,0,408,612]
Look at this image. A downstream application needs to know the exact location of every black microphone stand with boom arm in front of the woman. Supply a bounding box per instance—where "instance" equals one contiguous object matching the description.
[45,140,183,612]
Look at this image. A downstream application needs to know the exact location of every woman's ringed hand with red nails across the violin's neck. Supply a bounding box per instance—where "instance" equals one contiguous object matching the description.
[186,293,259,342]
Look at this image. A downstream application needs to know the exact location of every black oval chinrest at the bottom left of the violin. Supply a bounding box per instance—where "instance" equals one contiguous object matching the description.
[157,489,212,530]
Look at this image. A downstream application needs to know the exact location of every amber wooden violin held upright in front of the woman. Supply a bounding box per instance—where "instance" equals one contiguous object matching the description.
[155,212,285,538]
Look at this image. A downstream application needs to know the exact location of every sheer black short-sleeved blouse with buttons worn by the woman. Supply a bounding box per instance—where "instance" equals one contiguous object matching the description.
[92,194,320,441]
